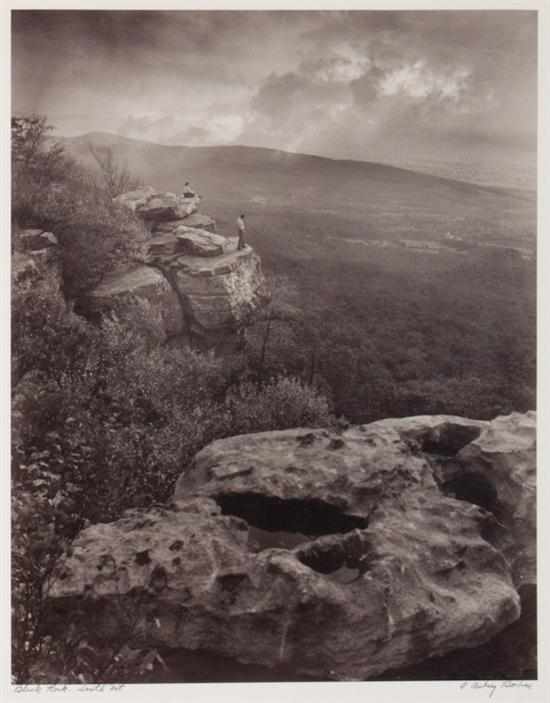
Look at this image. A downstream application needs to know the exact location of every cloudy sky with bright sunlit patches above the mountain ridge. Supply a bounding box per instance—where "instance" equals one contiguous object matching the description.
[12,11,537,186]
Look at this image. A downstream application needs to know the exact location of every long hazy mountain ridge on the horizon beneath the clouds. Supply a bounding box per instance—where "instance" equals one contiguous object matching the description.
[61,132,524,199]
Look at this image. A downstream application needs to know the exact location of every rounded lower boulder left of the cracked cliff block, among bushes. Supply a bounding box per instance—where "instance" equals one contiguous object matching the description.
[86,266,184,337]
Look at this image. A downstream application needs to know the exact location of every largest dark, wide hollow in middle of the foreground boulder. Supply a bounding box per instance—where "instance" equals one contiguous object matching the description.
[216,493,367,549]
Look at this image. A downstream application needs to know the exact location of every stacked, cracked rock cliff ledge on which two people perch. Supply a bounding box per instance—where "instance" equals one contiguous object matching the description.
[86,187,269,346]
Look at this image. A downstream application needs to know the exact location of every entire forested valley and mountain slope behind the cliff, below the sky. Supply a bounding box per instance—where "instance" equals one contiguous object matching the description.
[62,134,536,421]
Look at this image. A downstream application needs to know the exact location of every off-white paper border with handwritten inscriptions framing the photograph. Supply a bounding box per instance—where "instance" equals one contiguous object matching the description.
[0,0,550,703]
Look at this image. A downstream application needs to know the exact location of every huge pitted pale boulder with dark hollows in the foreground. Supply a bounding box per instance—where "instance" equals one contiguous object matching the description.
[48,413,535,679]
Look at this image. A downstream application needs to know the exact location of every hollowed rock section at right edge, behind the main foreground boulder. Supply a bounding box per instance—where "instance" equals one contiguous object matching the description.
[362,411,536,588]
